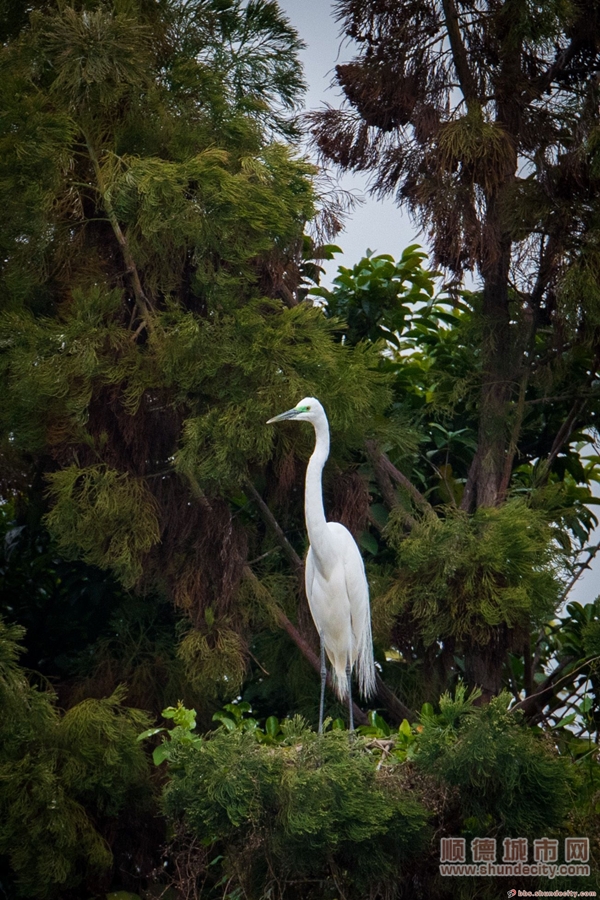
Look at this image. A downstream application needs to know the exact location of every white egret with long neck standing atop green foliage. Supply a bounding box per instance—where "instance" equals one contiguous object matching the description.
[267,397,375,732]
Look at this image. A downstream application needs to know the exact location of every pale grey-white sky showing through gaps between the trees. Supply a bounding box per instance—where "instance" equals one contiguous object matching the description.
[279,0,600,603]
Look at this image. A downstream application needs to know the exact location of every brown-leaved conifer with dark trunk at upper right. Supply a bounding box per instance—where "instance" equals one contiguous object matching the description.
[312,0,600,693]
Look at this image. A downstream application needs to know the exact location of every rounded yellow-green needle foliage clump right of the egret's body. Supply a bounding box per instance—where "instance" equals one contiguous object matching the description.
[376,500,563,646]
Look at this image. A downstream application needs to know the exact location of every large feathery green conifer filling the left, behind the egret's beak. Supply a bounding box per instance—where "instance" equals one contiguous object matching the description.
[1,2,388,708]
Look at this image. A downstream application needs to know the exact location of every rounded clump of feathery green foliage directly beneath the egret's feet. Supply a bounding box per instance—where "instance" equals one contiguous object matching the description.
[159,718,429,898]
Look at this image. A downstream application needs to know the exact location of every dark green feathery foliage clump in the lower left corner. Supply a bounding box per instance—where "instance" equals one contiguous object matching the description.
[0,621,149,898]
